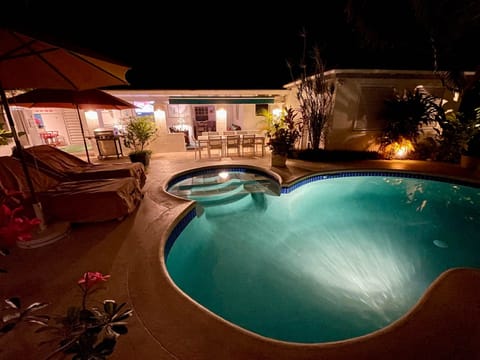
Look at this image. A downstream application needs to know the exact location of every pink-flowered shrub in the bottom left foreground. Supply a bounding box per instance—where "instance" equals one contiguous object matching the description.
[0,272,133,360]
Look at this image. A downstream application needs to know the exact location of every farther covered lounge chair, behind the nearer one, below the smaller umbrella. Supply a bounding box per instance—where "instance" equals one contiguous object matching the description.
[12,145,147,188]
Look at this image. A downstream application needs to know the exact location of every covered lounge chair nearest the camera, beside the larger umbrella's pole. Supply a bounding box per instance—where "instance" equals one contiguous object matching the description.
[0,156,143,223]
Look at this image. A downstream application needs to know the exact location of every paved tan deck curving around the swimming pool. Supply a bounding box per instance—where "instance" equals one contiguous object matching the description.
[0,152,480,360]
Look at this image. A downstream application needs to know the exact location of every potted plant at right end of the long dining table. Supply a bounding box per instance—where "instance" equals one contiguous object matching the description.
[264,107,303,167]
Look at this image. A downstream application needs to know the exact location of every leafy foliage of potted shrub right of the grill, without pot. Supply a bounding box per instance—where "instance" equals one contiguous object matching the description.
[123,116,157,153]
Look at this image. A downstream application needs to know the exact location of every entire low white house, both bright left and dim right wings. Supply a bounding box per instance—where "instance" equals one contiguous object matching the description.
[0,69,464,156]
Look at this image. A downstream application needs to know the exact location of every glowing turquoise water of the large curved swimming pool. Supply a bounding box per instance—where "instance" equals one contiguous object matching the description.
[166,174,480,343]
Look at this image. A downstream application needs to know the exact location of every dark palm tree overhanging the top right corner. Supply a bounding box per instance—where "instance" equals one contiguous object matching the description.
[345,0,480,114]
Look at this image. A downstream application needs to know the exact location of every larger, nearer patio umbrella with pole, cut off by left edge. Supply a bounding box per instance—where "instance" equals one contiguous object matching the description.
[0,28,129,239]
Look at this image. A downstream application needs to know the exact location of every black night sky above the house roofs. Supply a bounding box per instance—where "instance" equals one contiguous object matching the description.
[0,0,472,89]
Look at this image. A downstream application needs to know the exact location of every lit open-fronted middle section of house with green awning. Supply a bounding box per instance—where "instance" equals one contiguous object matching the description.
[108,89,287,152]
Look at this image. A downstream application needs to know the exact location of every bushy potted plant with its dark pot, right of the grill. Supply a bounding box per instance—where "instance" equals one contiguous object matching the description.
[123,116,157,167]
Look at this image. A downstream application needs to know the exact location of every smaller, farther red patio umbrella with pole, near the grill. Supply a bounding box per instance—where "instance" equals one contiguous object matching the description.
[8,89,136,162]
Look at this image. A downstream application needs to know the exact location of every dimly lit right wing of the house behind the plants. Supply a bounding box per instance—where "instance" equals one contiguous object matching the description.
[284,70,464,150]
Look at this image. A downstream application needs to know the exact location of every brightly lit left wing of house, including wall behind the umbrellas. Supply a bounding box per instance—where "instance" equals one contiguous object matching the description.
[0,89,287,155]
